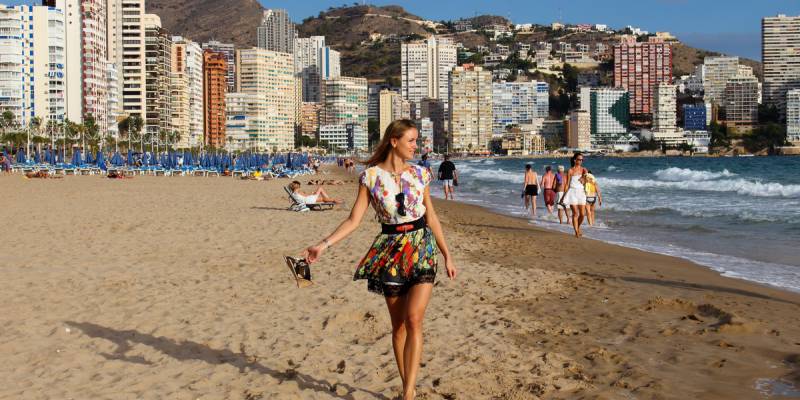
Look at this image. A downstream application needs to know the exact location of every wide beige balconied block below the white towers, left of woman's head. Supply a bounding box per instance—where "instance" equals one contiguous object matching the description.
[319,76,368,132]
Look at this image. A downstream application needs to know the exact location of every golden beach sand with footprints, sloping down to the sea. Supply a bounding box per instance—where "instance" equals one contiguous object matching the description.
[0,171,800,400]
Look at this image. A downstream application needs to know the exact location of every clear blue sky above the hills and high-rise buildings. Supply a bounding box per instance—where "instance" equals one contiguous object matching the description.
[0,0,800,59]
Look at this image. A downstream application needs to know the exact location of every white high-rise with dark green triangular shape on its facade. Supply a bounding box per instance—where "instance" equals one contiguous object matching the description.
[589,88,630,149]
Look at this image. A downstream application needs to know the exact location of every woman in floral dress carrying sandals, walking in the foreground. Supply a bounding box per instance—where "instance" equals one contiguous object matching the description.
[305,120,457,400]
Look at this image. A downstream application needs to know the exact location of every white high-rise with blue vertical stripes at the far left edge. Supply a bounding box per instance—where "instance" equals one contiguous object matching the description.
[0,5,67,126]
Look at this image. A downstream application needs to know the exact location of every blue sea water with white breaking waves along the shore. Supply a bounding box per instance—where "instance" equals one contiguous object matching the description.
[432,156,800,292]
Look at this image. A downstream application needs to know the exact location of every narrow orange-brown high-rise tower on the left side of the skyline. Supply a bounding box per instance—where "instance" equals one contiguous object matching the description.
[203,50,228,148]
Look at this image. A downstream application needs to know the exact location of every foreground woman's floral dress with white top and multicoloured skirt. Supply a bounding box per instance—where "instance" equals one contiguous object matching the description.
[353,165,437,296]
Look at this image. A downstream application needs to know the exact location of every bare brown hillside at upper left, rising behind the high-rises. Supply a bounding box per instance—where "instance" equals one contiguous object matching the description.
[146,0,264,47]
